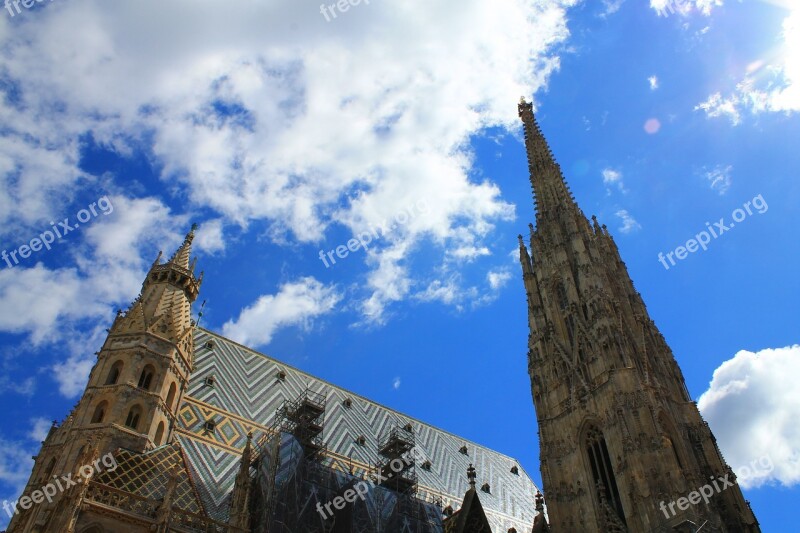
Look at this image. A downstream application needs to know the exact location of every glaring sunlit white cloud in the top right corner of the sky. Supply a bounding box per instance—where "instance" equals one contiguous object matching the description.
[695,6,800,126]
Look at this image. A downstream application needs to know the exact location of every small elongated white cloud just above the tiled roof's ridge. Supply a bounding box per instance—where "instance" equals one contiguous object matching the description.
[222,277,342,346]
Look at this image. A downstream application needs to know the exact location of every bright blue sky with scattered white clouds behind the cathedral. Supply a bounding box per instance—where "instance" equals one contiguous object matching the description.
[0,0,800,531]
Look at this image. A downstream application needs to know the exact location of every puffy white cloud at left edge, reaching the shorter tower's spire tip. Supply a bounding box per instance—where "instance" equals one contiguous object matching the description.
[0,196,188,346]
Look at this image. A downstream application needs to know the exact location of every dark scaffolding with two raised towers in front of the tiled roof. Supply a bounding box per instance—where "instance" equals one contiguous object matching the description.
[251,390,442,533]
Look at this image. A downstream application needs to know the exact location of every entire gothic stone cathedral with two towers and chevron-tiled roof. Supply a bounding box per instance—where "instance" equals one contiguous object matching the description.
[7,100,760,533]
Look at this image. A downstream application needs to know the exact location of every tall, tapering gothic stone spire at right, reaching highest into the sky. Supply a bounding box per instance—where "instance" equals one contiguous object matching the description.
[519,99,760,532]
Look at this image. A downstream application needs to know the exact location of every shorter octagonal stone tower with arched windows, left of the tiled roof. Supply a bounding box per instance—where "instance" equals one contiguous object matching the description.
[8,227,202,533]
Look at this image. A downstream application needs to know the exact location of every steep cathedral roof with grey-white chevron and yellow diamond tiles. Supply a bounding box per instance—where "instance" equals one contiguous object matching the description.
[177,328,537,532]
